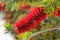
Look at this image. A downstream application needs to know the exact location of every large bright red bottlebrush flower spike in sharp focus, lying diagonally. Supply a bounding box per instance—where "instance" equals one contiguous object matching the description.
[12,7,46,34]
